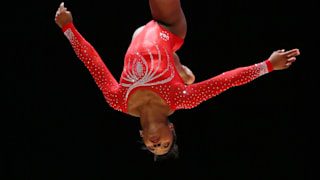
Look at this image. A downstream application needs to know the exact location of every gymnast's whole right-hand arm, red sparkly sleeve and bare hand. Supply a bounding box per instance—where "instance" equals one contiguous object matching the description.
[176,49,300,109]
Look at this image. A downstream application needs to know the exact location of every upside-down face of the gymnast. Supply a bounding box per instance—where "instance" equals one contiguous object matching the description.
[140,123,174,155]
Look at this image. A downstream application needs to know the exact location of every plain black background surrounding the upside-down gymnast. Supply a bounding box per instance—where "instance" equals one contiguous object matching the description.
[0,0,320,180]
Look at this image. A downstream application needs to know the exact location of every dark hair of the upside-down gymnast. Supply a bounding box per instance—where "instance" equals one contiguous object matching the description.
[141,119,179,162]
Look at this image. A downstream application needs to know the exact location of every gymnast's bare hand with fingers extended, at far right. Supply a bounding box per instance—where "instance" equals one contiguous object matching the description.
[269,49,300,70]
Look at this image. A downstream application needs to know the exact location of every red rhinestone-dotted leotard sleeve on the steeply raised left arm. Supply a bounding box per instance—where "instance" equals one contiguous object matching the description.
[62,23,122,111]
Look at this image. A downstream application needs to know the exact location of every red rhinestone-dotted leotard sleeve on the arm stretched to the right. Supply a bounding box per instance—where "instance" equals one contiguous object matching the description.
[175,60,273,109]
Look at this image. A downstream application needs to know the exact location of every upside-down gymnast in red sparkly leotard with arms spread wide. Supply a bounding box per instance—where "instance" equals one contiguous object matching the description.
[55,0,300,159]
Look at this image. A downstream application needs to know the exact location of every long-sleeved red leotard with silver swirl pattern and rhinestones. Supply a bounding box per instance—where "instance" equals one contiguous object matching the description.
[63,21,273,113]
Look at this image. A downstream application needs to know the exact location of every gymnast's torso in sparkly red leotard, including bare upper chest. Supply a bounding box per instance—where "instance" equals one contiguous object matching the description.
[120,21,184,114]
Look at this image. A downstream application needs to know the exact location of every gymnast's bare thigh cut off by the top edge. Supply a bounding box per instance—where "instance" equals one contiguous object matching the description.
[149,0,187,38]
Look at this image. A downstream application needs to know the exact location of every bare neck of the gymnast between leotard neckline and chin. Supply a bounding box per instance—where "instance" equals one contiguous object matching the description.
[140,105,168,131]
